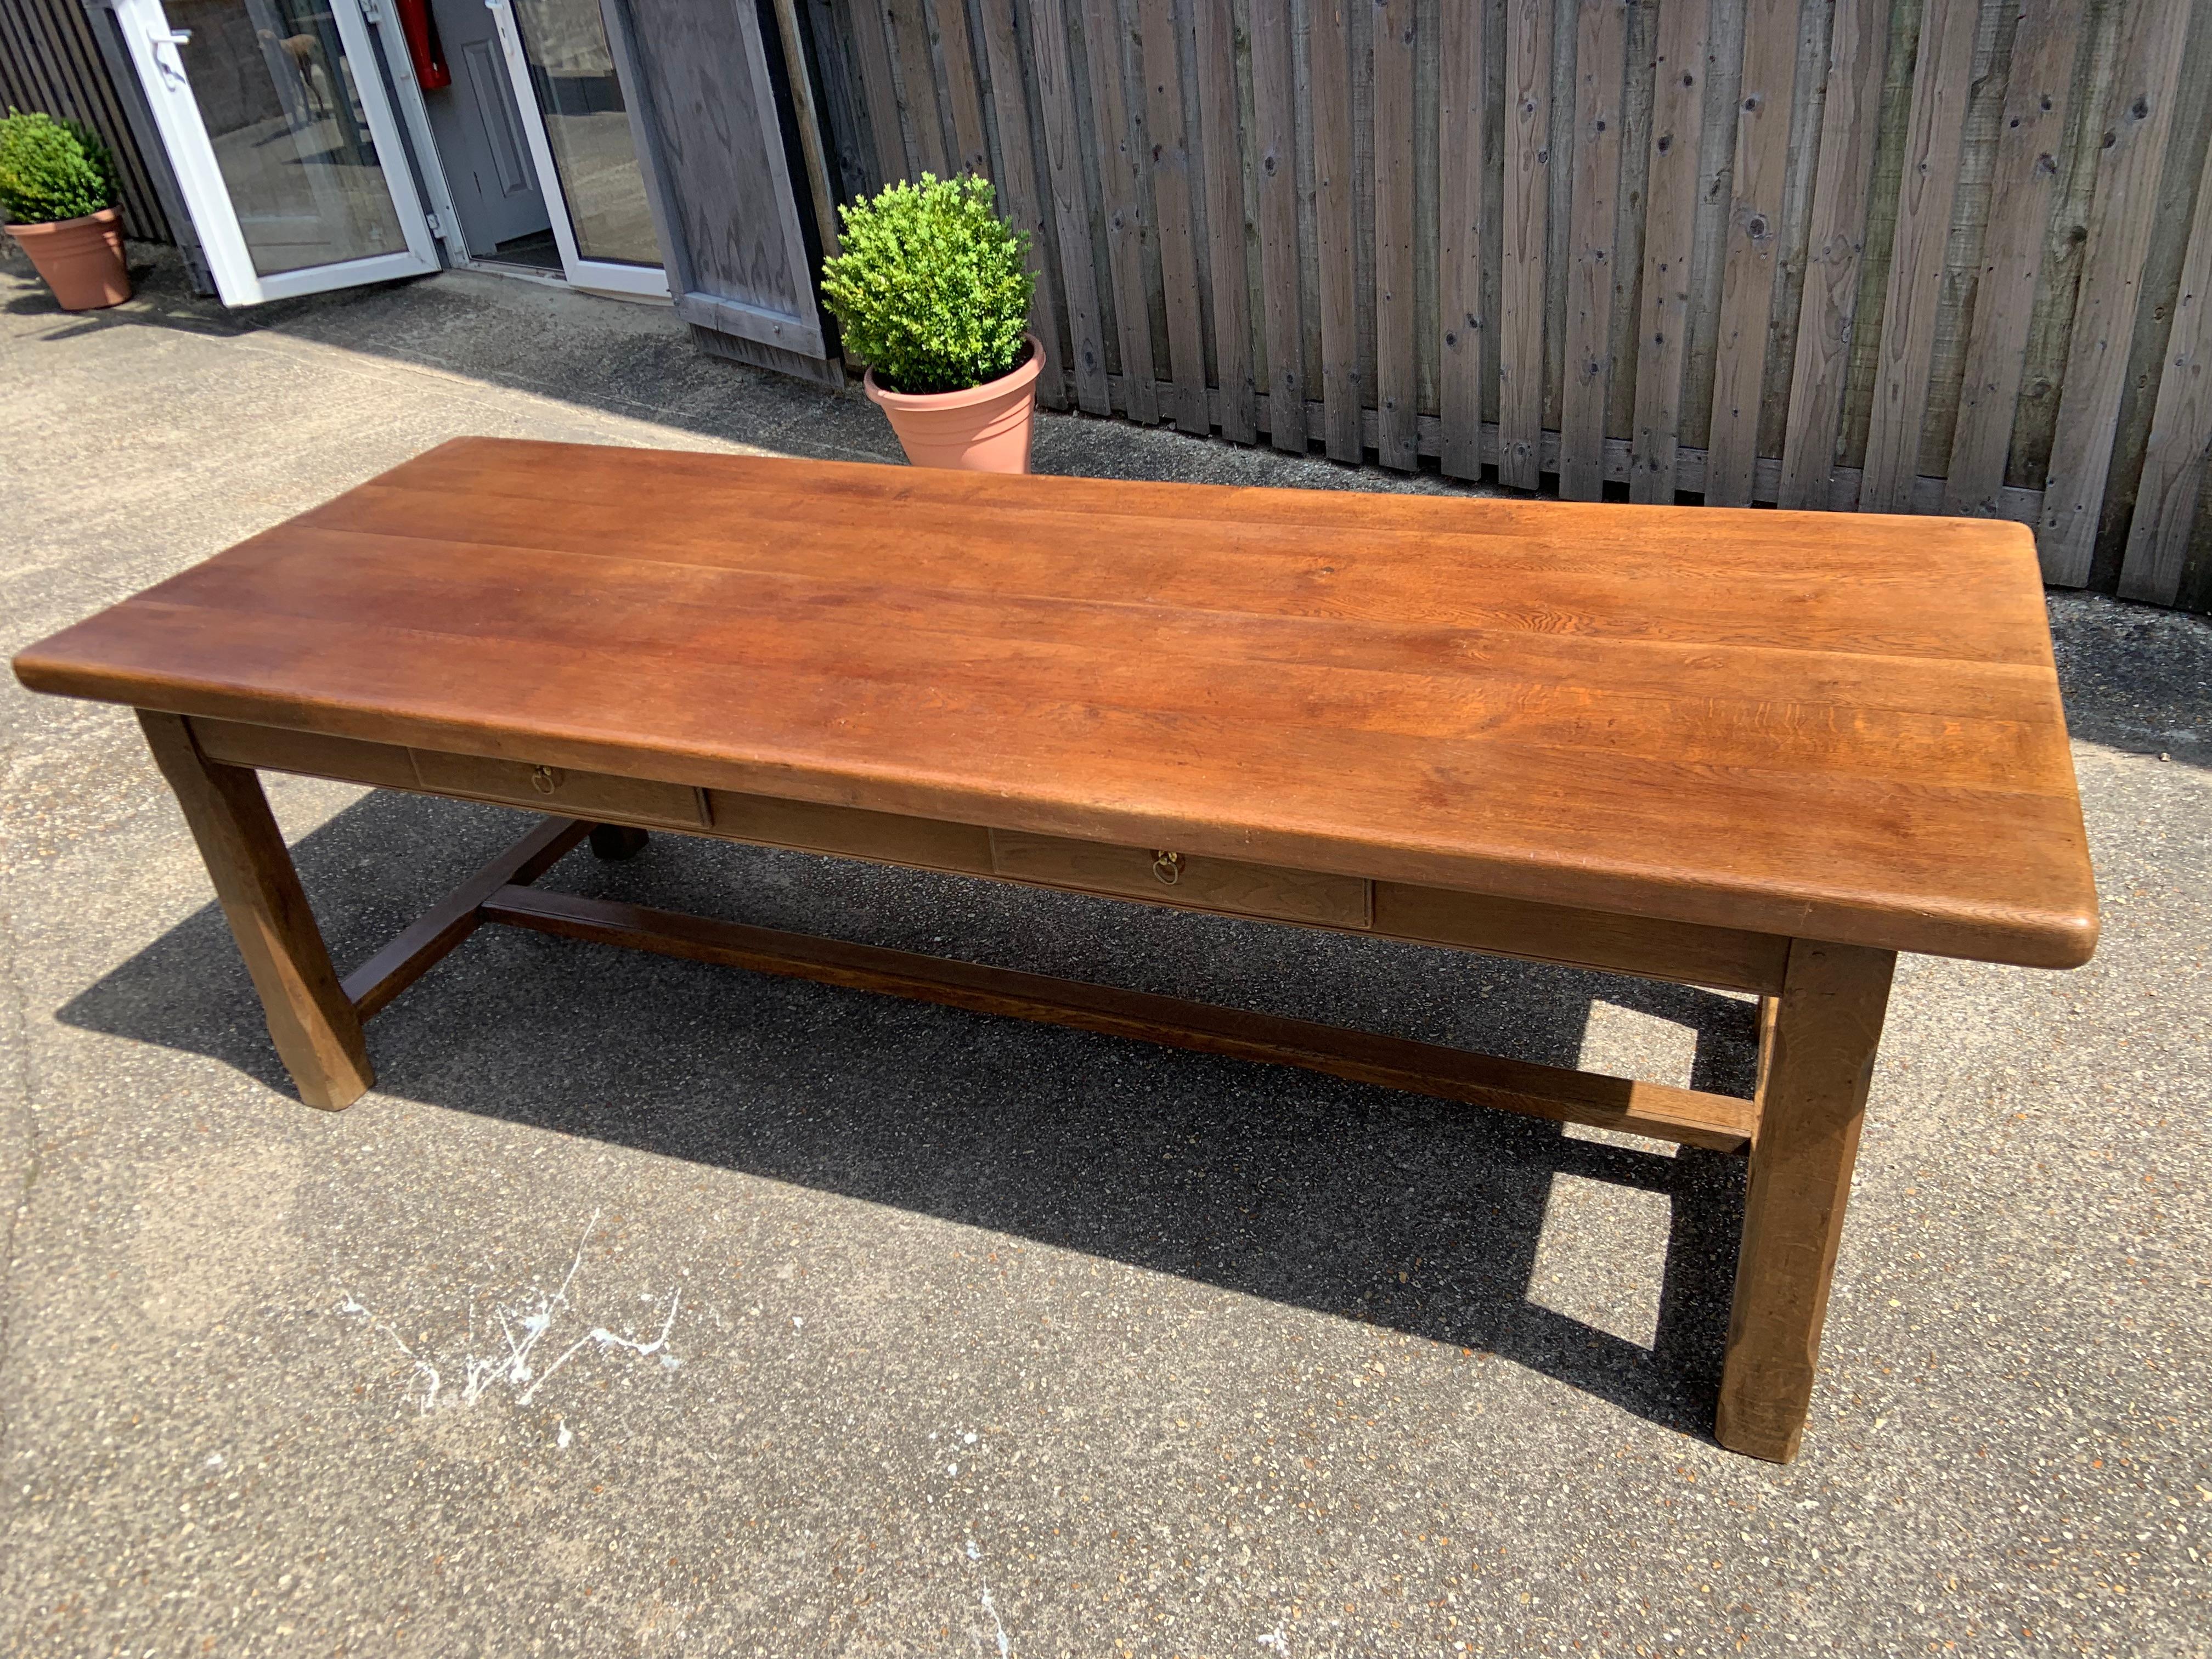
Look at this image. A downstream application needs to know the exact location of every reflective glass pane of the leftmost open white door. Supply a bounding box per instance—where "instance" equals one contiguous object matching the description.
[163,0,407,276]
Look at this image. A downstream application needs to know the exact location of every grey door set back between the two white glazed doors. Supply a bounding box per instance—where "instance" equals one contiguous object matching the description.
[422,0,553,259]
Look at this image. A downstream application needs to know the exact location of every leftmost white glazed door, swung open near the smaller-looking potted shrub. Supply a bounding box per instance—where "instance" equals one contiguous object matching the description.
[115,0,438,305]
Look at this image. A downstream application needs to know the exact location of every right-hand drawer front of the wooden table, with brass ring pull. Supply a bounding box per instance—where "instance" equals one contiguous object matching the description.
[991,830,1374,929]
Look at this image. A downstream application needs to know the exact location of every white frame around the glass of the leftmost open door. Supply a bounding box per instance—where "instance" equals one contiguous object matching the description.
[113,0,438,305]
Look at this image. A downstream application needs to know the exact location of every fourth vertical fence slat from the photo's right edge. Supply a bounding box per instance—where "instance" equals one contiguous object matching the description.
[1858,0,1982,513]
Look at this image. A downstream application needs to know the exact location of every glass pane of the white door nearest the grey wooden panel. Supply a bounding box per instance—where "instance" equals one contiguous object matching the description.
[513,0,662,266]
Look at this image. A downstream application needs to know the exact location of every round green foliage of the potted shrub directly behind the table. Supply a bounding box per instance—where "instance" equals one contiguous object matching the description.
[823,172,1037,392]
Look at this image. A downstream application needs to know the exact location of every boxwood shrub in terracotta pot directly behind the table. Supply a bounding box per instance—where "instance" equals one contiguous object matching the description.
[823,172,1044,473]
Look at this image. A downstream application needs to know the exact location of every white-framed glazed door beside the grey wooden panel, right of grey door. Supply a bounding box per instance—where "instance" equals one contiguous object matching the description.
[484,0,668,298]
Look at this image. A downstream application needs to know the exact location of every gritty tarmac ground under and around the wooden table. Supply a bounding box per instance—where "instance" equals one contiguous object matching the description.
[0,250,2212,1659]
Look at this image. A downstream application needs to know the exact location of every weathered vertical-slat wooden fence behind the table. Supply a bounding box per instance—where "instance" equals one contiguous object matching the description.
[803,0,2212,608]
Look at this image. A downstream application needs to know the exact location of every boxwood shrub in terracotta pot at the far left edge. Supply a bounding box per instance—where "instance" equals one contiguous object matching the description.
[0,111,131,312]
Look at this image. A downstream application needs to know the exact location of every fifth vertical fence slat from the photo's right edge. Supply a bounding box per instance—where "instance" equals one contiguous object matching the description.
[1776,0,1889,506]
